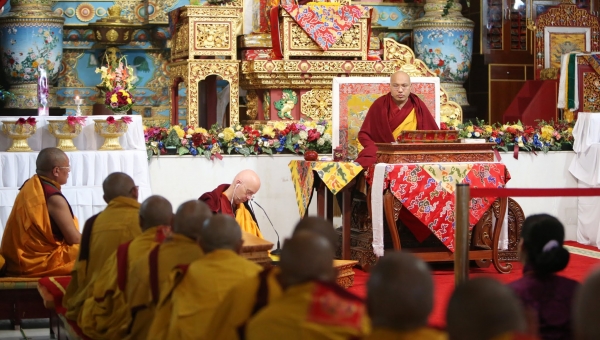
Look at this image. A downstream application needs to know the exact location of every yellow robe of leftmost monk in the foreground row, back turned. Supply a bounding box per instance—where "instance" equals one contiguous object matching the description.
[63,196,142,321]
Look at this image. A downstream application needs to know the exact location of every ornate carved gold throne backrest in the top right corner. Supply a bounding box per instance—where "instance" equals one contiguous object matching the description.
[534,0,600,79]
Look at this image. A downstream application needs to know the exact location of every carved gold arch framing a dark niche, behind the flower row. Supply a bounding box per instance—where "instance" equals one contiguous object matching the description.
[169,59,240,127]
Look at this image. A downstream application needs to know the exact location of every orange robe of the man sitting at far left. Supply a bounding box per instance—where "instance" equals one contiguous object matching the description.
[0,175,79,277]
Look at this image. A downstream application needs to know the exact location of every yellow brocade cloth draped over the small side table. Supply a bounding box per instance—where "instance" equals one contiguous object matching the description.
[288,160,363,217]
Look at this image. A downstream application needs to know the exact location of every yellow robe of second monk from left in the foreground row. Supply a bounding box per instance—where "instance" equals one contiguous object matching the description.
[77,227,158,340]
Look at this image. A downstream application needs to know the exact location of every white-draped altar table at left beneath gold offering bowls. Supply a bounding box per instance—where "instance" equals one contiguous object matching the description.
[0,116,152,244]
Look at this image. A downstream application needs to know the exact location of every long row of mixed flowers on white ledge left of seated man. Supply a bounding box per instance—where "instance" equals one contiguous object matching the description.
[144,121,331,159]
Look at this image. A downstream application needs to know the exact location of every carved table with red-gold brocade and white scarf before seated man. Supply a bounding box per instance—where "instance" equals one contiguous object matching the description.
[368,162,510,272]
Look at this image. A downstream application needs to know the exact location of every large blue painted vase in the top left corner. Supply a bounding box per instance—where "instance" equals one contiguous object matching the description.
[0,0,65,109]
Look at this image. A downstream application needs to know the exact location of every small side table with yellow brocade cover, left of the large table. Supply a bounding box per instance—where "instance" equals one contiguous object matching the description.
[288,160,363,260]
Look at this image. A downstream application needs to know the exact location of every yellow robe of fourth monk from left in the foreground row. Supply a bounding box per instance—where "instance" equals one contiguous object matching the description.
[147,250,262,340]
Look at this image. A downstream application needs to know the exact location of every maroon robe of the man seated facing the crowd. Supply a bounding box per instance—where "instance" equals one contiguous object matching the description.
[356,93,440,169]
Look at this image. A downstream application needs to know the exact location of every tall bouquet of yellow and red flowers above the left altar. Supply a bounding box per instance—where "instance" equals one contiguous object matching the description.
[96,56,137,112]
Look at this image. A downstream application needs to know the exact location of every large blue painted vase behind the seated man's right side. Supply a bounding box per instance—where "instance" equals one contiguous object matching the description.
[413,0,475,106]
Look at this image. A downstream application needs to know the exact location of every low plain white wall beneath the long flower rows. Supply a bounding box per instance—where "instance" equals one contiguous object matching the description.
[150,152,577,247]
